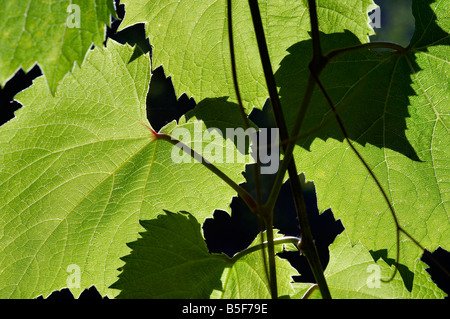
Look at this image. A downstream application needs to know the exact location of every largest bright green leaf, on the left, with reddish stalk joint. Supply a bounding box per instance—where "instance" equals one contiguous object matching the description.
[0,41,249,298]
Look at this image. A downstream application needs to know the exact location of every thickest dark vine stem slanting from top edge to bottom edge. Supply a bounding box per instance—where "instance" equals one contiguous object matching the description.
[249,0,331,299]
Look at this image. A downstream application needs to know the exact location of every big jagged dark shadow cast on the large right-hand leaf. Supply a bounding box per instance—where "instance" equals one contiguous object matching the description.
[275,31,420,161]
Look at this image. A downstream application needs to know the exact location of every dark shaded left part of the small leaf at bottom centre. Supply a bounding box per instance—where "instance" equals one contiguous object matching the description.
[111,211,228,299]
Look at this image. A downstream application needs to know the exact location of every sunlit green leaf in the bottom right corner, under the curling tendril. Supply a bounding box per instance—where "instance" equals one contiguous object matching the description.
[292,231,446,299]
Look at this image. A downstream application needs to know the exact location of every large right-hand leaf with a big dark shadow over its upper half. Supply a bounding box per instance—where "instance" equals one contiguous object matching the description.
[286,0,450,279]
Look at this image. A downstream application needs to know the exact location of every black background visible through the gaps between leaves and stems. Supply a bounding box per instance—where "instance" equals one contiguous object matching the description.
[0,0,450,299]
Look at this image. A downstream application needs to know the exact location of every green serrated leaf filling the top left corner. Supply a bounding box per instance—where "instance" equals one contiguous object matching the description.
[0,0,115,93]
